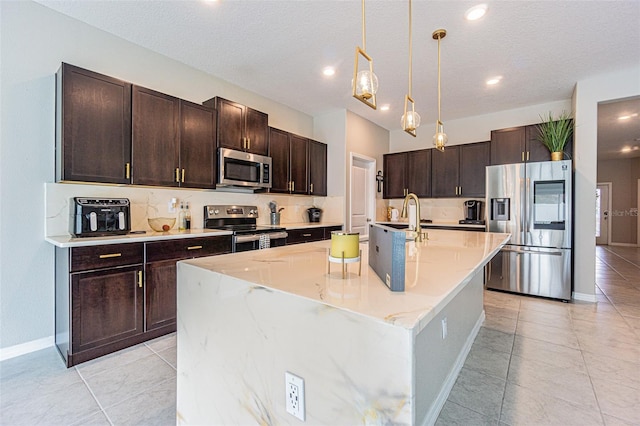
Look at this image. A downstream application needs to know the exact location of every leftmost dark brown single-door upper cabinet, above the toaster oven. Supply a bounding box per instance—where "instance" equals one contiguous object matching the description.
[56,64,131,183]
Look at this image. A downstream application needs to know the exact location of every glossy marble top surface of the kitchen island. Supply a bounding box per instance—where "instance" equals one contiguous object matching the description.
[181,229,510,334]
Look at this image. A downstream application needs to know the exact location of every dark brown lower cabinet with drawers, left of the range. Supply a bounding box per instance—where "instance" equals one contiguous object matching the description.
[55,235,231,367]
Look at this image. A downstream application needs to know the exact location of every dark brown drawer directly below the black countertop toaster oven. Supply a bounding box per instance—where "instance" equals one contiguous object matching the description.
[70,243,144,272]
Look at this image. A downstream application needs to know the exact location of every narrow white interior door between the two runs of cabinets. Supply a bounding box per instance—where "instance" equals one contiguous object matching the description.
[349,153,376,239]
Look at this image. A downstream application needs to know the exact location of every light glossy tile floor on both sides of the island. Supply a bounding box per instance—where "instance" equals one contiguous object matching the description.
[0,247,640,426]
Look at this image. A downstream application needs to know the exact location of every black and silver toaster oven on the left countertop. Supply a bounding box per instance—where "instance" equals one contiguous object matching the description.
[70,197,131,237]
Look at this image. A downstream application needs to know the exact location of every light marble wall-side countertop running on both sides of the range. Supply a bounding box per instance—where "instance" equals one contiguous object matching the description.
[45,222,342,248]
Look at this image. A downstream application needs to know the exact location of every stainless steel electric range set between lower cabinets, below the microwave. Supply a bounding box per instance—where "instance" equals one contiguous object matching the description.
[204,205,288,253]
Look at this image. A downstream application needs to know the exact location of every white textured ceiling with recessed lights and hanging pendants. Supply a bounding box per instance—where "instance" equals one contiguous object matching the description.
[40,0,640,156]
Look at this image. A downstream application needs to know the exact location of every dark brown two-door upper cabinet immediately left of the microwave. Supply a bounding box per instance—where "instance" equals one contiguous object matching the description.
[132,86,216,188]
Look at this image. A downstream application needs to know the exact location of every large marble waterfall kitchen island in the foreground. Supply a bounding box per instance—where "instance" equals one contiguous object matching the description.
[177,230,509,425]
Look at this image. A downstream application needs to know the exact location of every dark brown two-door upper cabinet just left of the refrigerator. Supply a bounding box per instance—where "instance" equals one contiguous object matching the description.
[431,142,491,198]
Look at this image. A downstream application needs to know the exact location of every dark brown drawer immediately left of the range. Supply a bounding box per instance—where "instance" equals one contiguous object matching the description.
[147,235,231,262]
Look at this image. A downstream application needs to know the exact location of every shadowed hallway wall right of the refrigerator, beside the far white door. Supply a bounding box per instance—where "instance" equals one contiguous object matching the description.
[598,158,640,244]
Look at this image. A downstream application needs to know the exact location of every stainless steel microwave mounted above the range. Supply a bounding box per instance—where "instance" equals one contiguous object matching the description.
[217,148,271,190]
